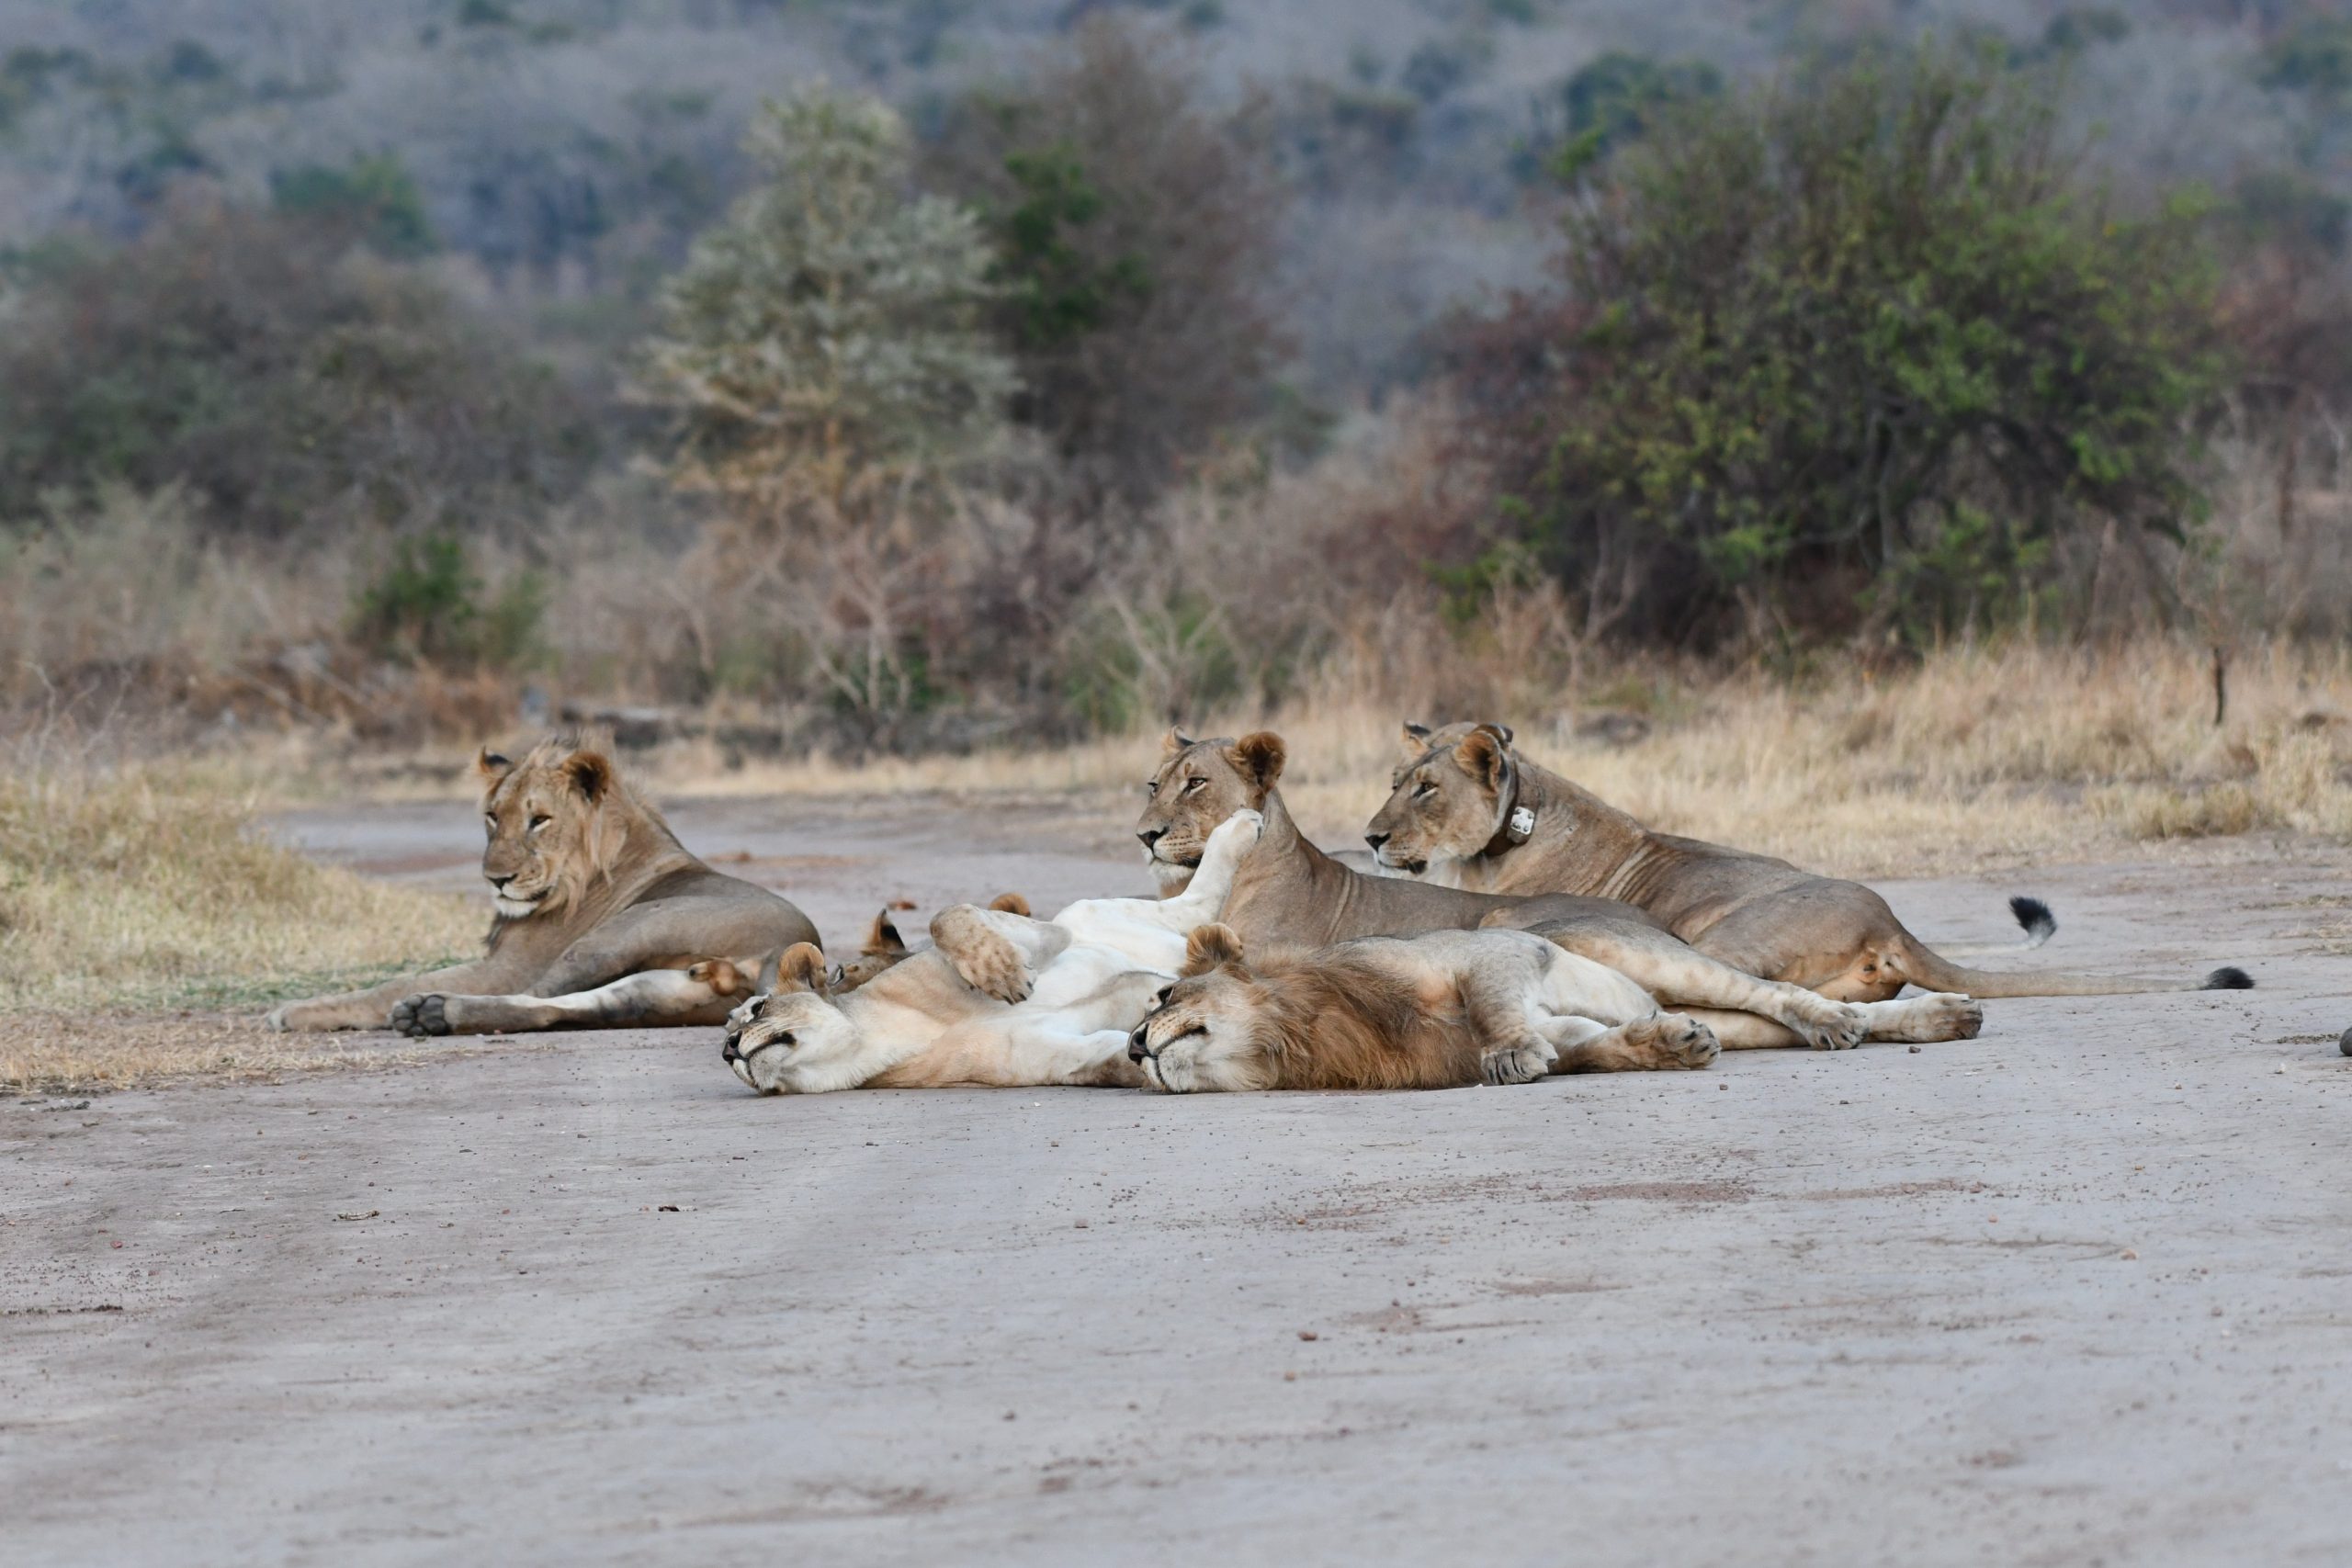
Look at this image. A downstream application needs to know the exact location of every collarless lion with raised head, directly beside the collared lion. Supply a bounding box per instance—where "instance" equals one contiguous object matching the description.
[1136,728,1983,1051]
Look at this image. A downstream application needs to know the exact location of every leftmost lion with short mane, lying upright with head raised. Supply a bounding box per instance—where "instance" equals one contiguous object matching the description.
[270,740,816,1037]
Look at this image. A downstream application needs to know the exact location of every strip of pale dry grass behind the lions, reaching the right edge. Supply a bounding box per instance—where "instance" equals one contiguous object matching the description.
[606,644,2352,877]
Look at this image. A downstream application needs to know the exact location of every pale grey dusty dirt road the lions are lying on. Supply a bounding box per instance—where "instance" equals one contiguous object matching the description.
[0,802,2352,1565]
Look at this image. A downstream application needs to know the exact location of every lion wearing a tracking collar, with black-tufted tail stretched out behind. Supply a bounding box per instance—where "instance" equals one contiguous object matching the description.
[1364,724,2253,1004]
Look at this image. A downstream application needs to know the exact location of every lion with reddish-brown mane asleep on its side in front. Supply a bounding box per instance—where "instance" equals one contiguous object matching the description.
[1126,926,1717,1093]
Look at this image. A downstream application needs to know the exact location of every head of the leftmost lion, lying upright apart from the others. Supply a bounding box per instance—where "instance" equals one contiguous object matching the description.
[475,740,626,919]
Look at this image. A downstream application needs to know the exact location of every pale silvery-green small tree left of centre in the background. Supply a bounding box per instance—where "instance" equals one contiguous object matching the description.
[644,87,1013,533]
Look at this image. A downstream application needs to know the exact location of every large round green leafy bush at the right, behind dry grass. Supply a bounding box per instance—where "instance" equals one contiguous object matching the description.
[1470,47,2222,644]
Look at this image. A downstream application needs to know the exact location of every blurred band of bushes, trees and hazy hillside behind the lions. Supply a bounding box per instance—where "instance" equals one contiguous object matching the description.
[0,0,2352,752]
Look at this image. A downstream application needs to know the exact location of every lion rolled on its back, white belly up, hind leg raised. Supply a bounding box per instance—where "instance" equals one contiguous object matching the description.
[719,811,1261,1093]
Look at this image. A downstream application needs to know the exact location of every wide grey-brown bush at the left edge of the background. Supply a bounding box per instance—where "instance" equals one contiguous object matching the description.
[0,197,597,536]
